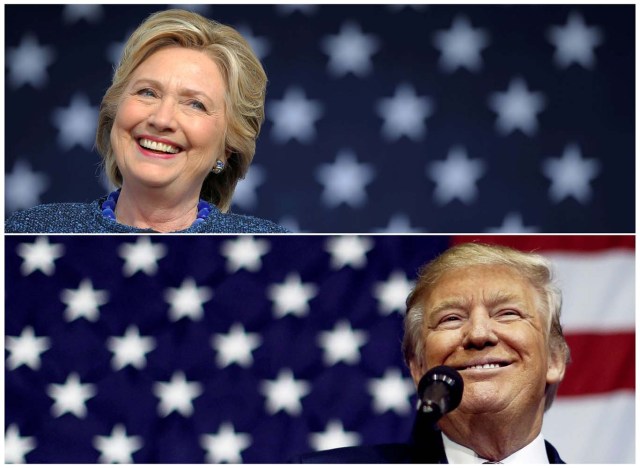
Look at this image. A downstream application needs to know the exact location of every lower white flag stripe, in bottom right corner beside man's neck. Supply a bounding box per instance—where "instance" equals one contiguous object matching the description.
[542,391,636,464]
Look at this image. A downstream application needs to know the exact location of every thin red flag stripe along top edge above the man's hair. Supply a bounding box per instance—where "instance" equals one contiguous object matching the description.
[451,235,636,252]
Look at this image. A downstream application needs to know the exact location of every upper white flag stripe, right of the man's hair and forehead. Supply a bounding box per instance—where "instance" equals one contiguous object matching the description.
[545,250,635,333]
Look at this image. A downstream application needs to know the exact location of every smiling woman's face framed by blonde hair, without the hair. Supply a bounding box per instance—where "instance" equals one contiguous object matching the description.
[111,47,227,197]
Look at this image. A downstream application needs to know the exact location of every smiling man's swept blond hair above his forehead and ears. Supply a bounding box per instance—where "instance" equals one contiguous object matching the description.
[402,243,570,410]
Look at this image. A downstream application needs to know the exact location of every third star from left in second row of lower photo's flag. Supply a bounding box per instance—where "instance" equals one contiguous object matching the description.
[267,273,318,318]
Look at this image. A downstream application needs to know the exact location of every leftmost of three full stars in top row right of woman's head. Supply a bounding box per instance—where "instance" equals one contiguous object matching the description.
[321,22,380,78]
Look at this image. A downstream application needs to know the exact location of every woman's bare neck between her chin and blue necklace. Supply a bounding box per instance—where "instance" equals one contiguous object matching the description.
[115,185,198,232]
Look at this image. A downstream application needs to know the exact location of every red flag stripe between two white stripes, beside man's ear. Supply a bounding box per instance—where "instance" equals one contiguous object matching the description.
[558,332,636,396]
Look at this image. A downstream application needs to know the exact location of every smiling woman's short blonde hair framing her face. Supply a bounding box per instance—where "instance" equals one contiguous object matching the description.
[96,10,267,212]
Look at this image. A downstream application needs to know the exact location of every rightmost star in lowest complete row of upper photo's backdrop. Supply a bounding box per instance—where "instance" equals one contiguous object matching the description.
[542,143,600,204]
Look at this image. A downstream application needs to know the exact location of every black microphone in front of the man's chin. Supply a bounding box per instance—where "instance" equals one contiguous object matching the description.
[418,366,464,424]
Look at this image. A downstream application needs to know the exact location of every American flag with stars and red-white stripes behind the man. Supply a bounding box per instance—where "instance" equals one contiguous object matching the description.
[4,235,635,463]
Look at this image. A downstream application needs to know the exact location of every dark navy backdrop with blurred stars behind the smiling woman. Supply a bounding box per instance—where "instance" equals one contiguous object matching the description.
[4,4,635,233]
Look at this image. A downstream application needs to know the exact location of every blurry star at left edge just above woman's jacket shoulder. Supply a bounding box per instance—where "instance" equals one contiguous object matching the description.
[4,159,49,211]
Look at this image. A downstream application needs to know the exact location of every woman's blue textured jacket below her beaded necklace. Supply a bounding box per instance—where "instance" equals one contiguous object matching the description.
[4,198,289,234]
